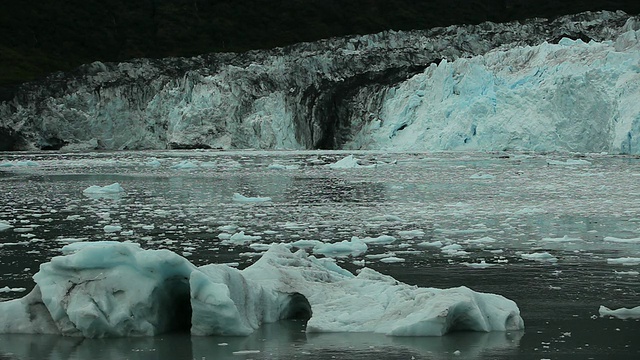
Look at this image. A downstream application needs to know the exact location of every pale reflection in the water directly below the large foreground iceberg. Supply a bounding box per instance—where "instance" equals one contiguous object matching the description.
[0,321,523,360]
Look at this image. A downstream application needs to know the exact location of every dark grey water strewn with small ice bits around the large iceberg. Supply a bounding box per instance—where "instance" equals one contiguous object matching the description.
[0,152,640,360]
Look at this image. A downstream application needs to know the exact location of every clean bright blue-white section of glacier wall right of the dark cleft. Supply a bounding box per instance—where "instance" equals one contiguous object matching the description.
[344,22,640,154]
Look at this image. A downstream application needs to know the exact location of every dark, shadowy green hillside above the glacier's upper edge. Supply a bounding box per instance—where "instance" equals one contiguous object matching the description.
[0,0,640,87]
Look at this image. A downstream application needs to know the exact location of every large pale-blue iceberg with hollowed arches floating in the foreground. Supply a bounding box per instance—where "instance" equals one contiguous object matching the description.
[0,242,524,337]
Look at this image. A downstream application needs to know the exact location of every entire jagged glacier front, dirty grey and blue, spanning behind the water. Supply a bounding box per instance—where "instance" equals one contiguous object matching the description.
[0,12,640,154]
